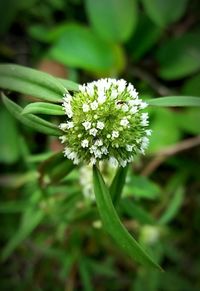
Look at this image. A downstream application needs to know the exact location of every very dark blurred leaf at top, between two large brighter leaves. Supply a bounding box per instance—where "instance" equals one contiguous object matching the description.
[128,14,163,61]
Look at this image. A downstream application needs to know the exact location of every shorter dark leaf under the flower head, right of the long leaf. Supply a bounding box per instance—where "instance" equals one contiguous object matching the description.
[109,166,128,205]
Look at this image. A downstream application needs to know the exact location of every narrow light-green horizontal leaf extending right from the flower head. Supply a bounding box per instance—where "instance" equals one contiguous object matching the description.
[146,96,200,107]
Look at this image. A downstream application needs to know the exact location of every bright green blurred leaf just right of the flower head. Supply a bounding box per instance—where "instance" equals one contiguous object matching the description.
[148,108,181,154]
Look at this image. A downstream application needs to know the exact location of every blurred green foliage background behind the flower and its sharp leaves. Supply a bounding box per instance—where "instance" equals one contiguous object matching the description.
[0,0,200,291]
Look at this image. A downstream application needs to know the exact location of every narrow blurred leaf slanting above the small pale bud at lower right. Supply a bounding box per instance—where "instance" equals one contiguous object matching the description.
[159,187,184,224]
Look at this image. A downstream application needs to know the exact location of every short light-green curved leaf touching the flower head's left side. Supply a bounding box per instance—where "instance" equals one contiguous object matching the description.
[22,102,65,115]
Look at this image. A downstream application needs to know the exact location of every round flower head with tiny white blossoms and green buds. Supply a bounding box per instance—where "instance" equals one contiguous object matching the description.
[59,78,151,167]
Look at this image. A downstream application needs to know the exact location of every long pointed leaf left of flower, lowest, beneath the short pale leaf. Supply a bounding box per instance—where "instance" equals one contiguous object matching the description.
[2,94,61,136]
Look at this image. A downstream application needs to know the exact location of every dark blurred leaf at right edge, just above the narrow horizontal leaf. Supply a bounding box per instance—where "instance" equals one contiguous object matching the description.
[181,73,200,97]
